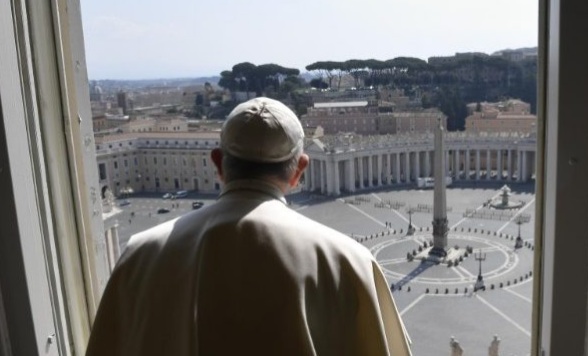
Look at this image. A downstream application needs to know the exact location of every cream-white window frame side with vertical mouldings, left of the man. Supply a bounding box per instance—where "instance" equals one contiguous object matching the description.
[0,0,108,355]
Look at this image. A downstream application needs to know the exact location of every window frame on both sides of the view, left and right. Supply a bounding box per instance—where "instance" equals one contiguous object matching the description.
[0,0,588,355]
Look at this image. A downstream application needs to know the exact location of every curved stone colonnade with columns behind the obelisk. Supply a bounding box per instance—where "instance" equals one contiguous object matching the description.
[303,135,535,196]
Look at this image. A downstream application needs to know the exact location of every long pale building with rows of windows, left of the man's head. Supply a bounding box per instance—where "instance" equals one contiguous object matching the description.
[96,132,220,197]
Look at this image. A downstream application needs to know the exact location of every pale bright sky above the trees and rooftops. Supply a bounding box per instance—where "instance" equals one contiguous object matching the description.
[80,0,538,80]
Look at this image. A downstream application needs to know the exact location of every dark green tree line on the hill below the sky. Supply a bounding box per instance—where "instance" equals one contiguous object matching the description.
[218,55,537,130]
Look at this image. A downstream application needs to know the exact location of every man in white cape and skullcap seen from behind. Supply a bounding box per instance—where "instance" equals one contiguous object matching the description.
[86,98,410,356]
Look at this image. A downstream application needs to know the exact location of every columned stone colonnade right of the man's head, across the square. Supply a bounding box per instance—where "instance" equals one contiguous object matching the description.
[303,132,537,196]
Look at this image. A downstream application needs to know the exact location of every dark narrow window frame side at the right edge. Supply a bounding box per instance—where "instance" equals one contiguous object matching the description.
[531,0,588,355]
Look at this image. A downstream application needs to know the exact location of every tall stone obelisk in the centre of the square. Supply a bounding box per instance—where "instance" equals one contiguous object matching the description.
[429,118,448,257]
